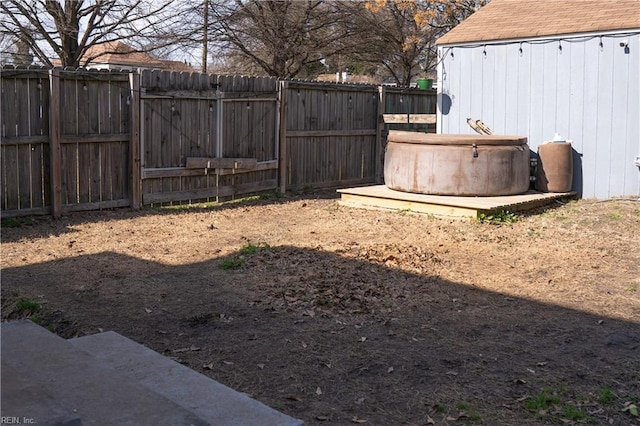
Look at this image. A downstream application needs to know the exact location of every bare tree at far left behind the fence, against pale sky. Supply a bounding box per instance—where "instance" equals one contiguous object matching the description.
[0,0,195,68]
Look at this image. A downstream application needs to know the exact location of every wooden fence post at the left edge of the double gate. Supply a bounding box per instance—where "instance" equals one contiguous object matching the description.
[129,71,142,210]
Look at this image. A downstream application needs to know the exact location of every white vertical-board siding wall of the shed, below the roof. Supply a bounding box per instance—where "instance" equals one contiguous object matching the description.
[438,34,640,198]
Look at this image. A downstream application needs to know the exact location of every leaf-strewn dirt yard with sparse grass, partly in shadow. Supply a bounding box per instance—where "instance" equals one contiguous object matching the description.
[1,194,640,426]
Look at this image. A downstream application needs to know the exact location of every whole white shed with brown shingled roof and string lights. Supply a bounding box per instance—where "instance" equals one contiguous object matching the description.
[438,0,640,198]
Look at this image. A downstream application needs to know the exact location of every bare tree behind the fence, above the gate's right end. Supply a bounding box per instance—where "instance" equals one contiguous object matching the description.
[210,0,362,77]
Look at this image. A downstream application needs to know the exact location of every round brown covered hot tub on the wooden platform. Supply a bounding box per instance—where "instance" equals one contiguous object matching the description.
[384,130,529,196]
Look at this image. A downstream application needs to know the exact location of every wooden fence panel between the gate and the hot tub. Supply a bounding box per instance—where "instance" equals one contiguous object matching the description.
[283,82,378,189]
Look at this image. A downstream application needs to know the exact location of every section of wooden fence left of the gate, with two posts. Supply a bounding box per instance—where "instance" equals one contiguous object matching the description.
[0,69,137,220]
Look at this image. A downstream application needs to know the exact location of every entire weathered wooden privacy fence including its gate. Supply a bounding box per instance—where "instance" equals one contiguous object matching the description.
[0,67,435,217]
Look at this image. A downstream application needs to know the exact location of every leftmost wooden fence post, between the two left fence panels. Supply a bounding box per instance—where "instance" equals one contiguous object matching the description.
[49,68,62,218]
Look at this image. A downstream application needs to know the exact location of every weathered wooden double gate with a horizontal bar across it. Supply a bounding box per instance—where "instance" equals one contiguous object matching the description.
[140,71,279,204]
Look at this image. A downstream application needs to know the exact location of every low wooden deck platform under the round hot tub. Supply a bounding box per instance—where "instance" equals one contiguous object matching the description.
[338,185,576,219]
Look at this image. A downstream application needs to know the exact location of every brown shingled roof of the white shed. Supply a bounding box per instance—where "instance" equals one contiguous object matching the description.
[437,0,640,44]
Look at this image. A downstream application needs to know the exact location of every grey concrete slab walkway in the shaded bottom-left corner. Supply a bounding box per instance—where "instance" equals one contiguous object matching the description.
[0,320,302,426]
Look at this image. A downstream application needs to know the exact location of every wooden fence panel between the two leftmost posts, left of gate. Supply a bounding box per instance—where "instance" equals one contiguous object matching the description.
[60,71,132,211]
